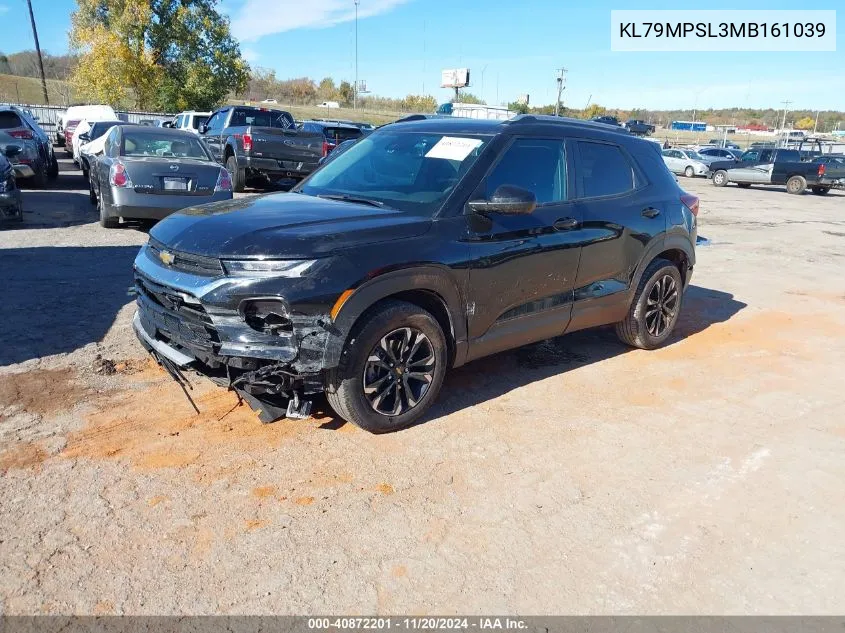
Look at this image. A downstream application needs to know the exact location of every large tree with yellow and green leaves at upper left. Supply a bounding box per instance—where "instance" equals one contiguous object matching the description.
[71,0,249,111]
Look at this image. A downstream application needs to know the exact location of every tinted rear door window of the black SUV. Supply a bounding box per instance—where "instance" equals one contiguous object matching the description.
[576,141,634,198]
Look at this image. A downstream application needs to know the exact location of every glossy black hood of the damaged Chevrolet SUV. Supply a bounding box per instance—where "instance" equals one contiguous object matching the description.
[150,193,431,259]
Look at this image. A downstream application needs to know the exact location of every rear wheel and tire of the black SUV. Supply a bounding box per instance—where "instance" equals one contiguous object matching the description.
[616,258,684,349]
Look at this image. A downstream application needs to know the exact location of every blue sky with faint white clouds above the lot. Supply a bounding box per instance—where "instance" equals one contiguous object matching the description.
[0,0,845,110]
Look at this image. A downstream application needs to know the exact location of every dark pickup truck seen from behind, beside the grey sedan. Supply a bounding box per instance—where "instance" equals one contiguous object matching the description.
[198,106,325,192]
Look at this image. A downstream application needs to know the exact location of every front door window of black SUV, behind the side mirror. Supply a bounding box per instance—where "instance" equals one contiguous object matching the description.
[486,138,567,204]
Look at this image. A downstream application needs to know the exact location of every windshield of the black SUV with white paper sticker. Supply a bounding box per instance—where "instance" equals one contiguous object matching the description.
[298,129,487,215]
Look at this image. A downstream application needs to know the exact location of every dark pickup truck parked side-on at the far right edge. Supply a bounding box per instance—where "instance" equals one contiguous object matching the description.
[710,148,845,195]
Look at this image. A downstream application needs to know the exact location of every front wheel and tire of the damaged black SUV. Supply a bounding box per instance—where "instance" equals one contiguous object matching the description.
[326,300,448,433]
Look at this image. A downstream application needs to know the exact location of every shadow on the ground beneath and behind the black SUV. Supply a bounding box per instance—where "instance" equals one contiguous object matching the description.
[314,286,747,429]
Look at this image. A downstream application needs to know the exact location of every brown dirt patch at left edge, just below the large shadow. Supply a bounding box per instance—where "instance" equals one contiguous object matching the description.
[0,367,90,420]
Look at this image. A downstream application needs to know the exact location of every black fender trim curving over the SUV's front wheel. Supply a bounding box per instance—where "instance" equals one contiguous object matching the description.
[323,265,467,368]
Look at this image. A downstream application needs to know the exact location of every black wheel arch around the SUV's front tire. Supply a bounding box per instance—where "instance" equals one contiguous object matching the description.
[323,265,467,368]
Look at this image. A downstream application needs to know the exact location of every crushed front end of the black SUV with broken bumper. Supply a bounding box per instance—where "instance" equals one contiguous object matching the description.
[133,238,332,422]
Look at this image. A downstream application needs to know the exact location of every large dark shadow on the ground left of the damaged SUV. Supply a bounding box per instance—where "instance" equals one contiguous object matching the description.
[0,246,139,366]
